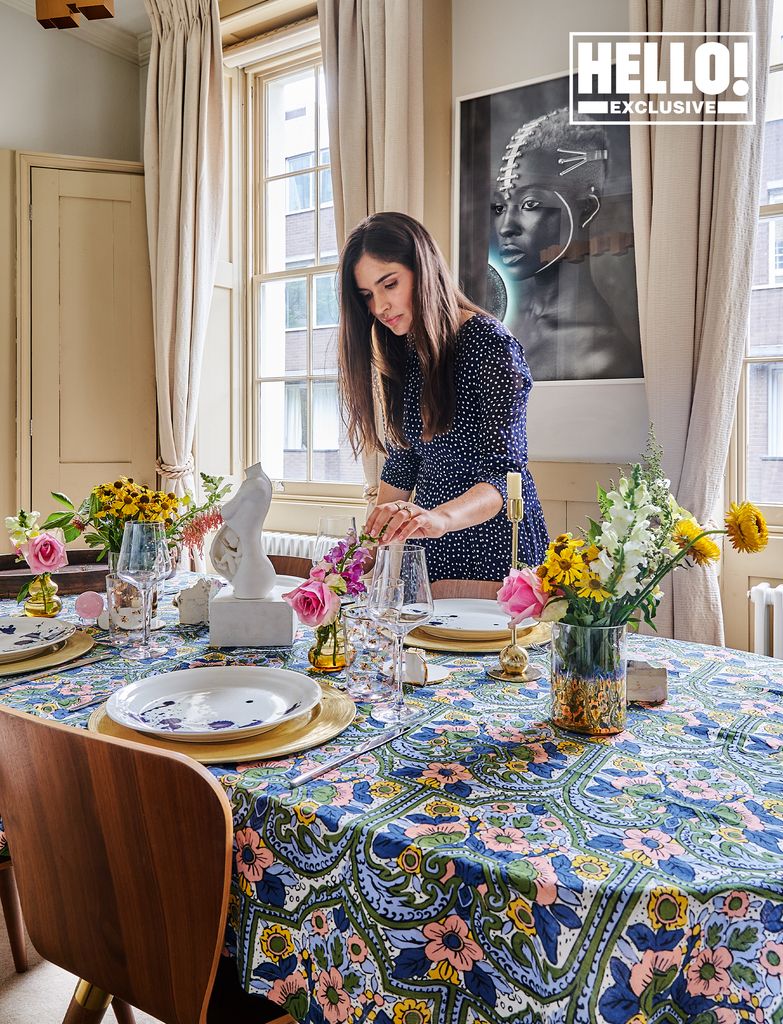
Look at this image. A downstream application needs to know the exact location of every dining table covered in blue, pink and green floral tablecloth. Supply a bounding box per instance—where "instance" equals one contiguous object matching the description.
[0,575,783,1024]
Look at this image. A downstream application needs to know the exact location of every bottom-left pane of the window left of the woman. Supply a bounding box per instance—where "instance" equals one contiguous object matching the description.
[258,381,307,480]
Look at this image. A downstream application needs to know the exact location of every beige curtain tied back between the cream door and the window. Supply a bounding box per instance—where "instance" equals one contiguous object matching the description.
[144,0,226,495]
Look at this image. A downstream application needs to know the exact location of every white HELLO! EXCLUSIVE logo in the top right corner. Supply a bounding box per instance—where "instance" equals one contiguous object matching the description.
[569,32,755,125]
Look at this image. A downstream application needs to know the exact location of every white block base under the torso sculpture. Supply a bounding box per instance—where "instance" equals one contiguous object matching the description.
[210,586,294,647]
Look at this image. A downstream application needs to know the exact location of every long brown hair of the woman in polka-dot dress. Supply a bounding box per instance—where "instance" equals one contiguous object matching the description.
[338,213,483,453]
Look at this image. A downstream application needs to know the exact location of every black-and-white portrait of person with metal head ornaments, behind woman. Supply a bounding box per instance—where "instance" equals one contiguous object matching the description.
[455,75,643,381]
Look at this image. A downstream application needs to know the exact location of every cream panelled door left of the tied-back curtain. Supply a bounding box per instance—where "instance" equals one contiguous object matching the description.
[30,167,157,515]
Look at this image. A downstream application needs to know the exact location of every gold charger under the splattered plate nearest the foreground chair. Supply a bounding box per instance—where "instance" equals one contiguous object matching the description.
[87,683,356,765]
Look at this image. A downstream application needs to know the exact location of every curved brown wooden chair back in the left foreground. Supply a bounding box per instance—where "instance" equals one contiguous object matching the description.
[0,708,232,1024]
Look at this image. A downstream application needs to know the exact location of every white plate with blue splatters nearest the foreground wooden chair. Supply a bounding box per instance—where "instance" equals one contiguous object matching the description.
[106,665,321,743]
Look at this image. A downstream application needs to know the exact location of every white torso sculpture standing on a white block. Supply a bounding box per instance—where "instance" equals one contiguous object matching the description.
[210,463,276,599]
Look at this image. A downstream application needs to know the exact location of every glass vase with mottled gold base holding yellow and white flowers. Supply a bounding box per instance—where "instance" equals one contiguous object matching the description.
[552,623,627,736]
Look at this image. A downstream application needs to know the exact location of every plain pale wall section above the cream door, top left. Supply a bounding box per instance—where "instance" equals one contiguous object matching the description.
[0,3,140,160]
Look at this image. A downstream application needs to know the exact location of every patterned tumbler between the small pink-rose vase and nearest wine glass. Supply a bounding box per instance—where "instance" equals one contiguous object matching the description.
[343,604,394,703]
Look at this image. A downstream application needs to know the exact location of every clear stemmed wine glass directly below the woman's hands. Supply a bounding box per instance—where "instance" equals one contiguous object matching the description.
[367,544,433,725]
